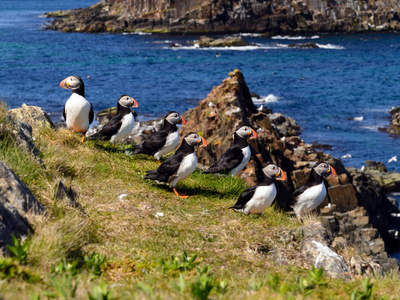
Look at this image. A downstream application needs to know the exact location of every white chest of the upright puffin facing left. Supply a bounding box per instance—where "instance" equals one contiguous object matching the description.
[65,93,91,132]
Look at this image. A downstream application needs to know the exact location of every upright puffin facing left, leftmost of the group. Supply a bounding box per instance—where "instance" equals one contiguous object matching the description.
[60,76,94,142]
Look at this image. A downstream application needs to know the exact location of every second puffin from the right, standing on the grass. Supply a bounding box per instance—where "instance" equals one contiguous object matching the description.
[229,163,286,215]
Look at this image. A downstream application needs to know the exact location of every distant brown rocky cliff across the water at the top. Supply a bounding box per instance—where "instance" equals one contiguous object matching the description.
[48,0,400,34]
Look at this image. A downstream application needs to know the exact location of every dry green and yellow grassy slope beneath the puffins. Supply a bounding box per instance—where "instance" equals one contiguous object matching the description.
[0,107,399,299]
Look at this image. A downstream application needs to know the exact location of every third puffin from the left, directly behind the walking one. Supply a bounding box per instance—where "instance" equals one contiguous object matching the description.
[132,111,186,162]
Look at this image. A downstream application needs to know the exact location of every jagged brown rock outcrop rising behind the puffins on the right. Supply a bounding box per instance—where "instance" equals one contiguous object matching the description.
[177,70,400,277]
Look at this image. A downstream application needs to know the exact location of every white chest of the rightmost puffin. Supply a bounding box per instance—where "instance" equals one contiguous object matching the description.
[293,182,326,216]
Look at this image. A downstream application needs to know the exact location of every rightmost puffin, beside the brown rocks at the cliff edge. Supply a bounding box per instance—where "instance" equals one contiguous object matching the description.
[288,162,337,218]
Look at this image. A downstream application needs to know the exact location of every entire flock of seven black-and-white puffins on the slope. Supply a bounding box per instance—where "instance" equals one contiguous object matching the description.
[60,76,336,217]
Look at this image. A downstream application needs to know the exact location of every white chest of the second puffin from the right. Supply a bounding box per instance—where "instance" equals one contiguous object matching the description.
[243,184,276,215]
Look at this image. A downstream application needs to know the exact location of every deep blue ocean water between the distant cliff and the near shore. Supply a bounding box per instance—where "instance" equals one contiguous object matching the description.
[0,0,400,177]
